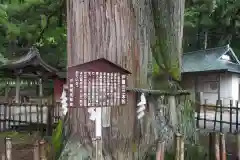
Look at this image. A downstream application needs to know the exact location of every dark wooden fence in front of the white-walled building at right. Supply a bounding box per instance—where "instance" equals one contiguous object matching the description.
[195,100,240,133]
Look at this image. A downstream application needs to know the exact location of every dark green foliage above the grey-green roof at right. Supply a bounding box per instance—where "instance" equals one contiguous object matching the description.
[184,0,240,51]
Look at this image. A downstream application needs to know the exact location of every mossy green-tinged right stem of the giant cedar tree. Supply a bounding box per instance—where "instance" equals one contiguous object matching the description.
[152,0,185,80]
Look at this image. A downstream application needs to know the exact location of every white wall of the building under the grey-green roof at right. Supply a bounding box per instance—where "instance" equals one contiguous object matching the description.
[182,73,239,106]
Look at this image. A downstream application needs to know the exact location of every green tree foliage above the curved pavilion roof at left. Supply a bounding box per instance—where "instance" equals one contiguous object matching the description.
[0,0,66,69]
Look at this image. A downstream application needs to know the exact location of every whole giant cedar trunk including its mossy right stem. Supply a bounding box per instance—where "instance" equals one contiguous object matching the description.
[62,0,184,160]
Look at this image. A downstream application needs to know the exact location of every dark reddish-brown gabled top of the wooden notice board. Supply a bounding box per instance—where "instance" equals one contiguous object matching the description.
[69,58,131,74]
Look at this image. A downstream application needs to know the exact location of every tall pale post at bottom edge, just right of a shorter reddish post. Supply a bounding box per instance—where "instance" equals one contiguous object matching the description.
[175,133,184,160]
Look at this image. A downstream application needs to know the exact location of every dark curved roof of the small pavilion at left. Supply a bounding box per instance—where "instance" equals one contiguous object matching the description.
[0,47,58,78]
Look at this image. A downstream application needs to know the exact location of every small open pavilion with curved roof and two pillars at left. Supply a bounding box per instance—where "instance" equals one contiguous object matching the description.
[0,47,58,103]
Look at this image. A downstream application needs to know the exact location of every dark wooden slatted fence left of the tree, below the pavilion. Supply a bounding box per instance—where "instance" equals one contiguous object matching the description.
[0,103,61,133]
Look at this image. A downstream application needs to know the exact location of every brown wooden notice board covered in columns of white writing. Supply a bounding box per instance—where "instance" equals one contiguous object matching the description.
[68,57,130,107]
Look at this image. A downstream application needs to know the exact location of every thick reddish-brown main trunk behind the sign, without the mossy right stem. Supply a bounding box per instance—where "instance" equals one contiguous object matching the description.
[63,0,156,160]
